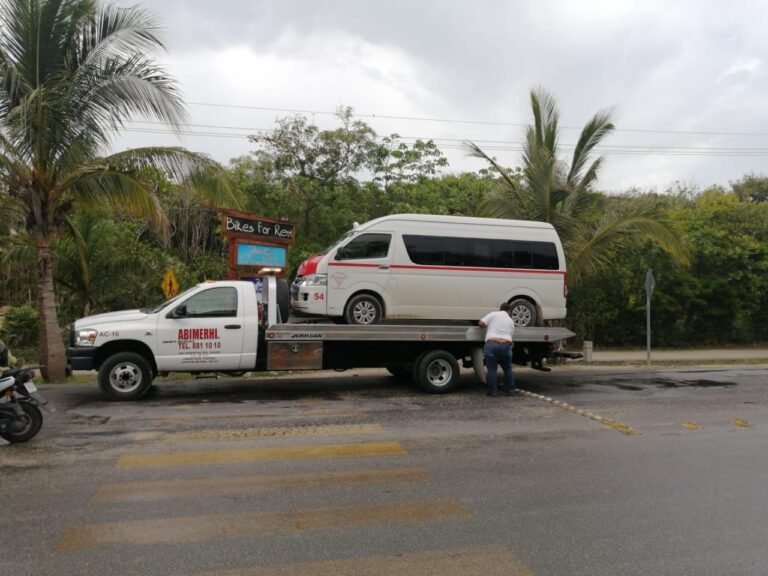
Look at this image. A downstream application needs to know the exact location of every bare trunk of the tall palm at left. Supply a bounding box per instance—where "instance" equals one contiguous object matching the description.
[37,234,67,382]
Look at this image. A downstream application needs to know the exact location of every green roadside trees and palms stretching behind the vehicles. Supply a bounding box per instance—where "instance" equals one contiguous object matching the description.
[0,0,768,380]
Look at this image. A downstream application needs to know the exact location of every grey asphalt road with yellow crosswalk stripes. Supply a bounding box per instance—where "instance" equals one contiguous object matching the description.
[0,365,768,576]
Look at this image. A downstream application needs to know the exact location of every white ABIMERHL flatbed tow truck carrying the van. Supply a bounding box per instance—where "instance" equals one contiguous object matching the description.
[67,277,580,400]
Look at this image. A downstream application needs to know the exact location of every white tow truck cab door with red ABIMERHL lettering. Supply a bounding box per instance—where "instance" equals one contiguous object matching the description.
[156,286,245,372]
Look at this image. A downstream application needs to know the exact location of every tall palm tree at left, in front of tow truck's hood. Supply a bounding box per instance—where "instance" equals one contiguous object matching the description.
[0,0,234,380]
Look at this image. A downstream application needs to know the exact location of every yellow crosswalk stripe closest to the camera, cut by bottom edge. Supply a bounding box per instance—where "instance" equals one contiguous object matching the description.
[188,546,534,576]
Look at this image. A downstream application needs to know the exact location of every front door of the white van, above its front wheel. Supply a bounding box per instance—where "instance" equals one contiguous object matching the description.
[327,231,392,316]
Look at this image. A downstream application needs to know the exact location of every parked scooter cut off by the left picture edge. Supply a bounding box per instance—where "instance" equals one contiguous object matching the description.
[0,366,55,444]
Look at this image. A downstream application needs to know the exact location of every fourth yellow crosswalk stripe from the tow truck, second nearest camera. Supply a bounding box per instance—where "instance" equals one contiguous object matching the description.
[56,498,472,552]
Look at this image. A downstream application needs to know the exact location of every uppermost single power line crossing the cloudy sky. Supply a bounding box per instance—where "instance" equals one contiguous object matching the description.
[188,102,768,137]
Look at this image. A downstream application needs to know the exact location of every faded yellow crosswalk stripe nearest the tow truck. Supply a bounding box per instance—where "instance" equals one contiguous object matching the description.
[152,424,383,444]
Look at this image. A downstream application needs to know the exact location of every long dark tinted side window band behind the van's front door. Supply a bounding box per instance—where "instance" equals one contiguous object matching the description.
[403,235,559,270]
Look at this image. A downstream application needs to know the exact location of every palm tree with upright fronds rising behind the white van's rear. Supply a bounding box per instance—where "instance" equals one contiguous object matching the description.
[467,88,688,284]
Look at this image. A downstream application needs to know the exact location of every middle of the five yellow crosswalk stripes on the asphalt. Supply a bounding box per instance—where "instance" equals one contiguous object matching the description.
[92,468,429,502]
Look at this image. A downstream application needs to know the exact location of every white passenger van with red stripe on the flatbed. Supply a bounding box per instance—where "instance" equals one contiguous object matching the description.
[291,214,568,326]
